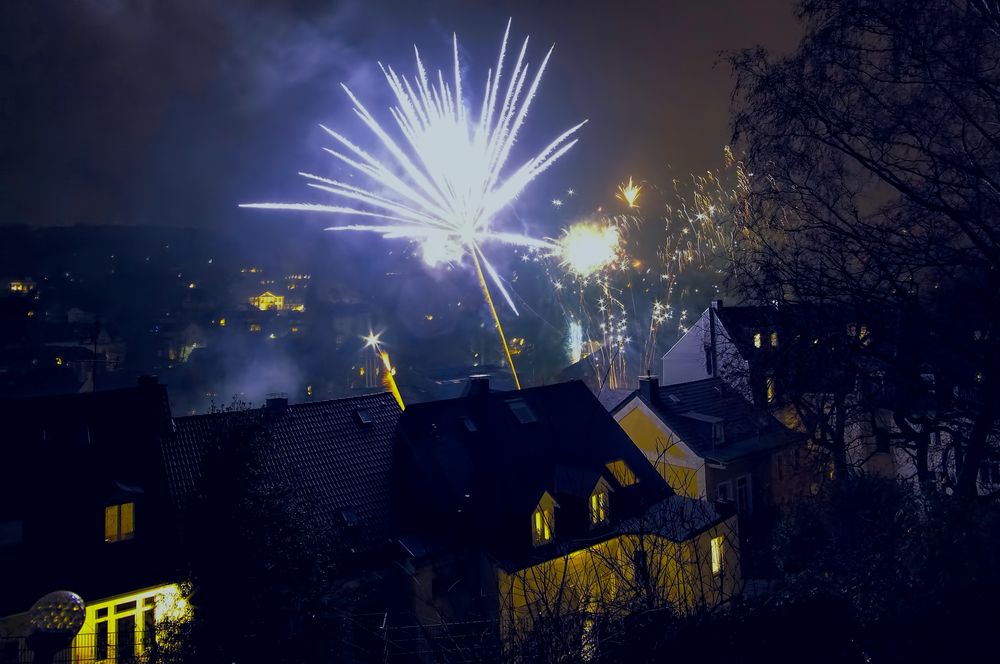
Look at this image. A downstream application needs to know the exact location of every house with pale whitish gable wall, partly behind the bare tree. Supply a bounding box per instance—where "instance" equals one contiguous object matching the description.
[662,300,907,475]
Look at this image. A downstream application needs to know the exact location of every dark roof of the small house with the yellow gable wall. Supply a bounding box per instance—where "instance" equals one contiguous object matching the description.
[620,378,801,462]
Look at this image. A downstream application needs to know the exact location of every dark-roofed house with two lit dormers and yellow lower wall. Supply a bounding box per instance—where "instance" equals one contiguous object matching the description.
[393,376,740,649]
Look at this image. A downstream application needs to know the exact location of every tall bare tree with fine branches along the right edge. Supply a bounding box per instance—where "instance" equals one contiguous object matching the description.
[731,0,1000,495]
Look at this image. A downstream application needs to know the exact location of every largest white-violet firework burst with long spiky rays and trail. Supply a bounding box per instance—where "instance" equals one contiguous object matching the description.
[241,21,586,389]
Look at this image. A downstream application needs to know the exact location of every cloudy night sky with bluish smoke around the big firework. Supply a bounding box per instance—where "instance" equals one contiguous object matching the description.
[0,0,799,227]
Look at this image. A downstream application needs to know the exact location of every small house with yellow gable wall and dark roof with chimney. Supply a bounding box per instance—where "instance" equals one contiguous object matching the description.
[611,375,817,571]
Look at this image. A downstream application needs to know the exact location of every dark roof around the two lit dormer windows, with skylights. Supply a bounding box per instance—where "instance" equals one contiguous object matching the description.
[397,381,671,560]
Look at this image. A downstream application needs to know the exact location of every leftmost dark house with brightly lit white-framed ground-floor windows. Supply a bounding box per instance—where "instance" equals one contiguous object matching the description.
[0,377,185,662]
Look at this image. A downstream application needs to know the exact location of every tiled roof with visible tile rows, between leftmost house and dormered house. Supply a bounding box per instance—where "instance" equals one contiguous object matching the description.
[164,392,400,550]
